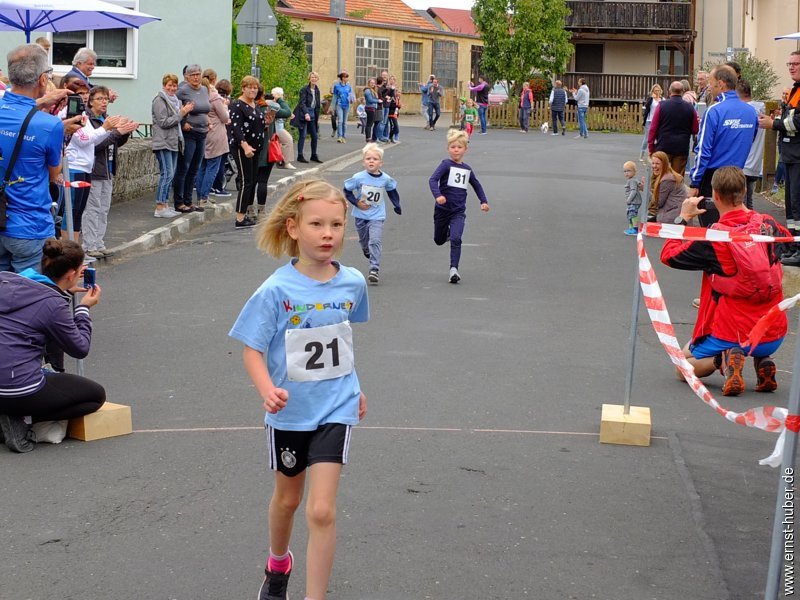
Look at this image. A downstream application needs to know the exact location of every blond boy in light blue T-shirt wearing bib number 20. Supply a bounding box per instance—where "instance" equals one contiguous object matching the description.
[344,143,402,283]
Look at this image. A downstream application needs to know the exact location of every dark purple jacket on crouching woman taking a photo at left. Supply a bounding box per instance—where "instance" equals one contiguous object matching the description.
[0,269,92,396]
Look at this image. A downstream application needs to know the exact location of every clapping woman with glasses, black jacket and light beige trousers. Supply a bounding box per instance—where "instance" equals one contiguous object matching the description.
[83,85,139,258]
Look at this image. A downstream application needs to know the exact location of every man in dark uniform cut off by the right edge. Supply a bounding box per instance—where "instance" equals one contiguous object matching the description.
[758,50,800,267]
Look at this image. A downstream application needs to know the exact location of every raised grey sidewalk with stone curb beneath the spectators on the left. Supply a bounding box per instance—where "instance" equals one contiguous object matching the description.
[100,115,432,261]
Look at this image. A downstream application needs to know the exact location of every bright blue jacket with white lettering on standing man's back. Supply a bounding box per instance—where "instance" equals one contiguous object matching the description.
[689,91,758,188]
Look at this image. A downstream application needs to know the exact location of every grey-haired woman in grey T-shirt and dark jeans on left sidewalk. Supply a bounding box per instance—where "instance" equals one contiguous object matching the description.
[173,64,211,213]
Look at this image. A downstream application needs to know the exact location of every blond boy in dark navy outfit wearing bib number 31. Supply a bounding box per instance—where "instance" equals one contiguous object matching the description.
[428,129,489,283]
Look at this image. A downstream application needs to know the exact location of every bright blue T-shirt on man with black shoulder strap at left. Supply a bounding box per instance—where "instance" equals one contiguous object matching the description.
[0,91,64,240]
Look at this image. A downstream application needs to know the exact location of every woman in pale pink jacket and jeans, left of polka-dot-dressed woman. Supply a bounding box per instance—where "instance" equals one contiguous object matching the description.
[196,69,231,208]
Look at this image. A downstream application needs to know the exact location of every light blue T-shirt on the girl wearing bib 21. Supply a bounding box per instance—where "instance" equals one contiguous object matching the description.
[228,259,369,431]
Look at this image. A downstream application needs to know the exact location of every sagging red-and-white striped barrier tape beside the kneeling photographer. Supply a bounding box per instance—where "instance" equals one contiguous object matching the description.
[636,232,800,467]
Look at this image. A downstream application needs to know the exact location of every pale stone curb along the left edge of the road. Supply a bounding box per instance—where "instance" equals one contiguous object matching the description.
[101,148,361,261]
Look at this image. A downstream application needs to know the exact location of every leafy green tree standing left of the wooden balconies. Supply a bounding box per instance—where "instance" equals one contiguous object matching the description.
[472,0,573,92]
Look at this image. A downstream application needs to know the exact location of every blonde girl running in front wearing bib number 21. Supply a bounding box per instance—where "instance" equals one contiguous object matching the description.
[229,180,369,600]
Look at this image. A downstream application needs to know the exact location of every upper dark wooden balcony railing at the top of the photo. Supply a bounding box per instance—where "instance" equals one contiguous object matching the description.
[566,0,693,34]
